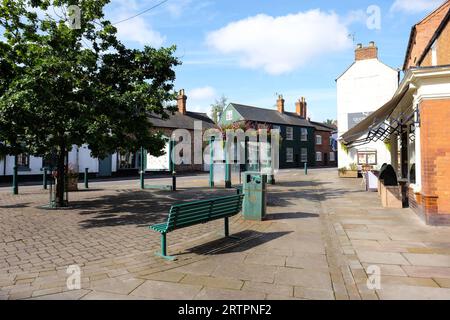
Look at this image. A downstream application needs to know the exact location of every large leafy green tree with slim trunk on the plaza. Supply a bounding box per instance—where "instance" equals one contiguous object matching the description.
[0,0,180,206]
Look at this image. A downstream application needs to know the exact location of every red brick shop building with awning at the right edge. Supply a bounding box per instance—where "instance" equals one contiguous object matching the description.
[344,0,450,225]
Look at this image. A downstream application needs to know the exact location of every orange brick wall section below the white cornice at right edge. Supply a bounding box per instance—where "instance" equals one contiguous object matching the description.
[420,99,450,221]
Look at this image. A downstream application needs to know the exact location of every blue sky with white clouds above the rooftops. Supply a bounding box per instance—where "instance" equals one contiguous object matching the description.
[4,0,444,121]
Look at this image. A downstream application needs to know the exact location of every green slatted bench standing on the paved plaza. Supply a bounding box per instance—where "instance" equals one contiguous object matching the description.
[149,194,244,260]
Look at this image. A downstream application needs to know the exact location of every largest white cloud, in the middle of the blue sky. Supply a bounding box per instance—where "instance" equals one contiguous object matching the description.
[206,9,352,75]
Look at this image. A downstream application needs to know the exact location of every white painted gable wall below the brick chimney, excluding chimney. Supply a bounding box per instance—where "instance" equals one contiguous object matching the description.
[336,59,398,168]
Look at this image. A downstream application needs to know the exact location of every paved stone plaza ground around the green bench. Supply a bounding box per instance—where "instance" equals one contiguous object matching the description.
[0,169,450,299]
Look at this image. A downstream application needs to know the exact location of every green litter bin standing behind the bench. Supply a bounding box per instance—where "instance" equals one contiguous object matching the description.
[242,171,267,221]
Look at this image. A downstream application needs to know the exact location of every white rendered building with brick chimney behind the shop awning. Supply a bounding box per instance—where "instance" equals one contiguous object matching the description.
[336,42,399,168]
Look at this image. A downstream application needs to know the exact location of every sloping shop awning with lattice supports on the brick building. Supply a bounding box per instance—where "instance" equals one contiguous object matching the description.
[341,87,408,145]
